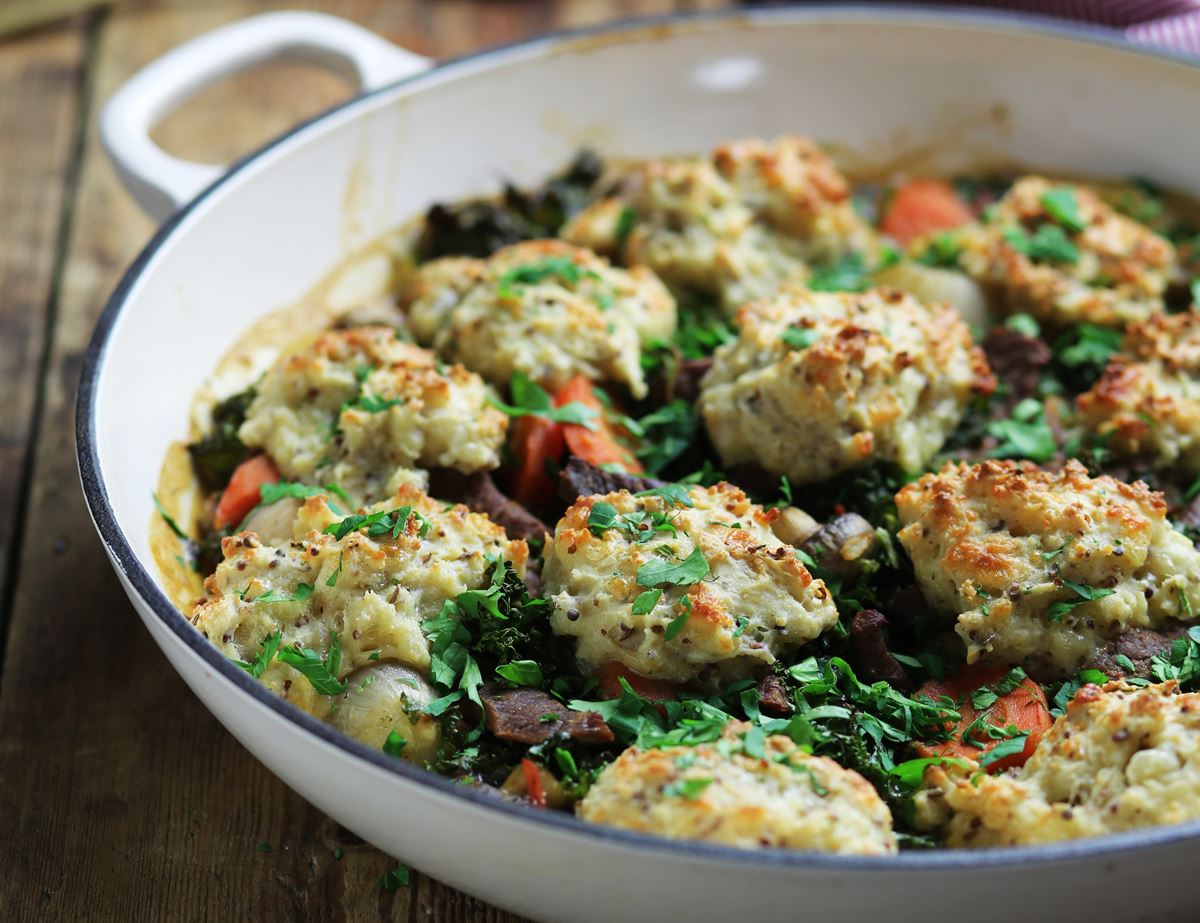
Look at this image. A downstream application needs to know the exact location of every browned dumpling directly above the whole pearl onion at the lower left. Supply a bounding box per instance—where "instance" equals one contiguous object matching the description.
[191,486,529,759]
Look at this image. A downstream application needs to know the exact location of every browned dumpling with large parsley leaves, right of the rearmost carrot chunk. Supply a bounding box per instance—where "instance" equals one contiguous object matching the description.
[955,176,1175,326]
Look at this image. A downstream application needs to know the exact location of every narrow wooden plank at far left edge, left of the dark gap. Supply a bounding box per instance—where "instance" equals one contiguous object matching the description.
[0,23,85,636]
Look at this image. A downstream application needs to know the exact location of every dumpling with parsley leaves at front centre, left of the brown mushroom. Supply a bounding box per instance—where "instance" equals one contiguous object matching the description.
[542,484,838,682]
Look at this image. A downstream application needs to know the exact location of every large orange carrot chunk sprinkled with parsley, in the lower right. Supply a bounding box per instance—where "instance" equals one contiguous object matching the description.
[917,666,1052,773]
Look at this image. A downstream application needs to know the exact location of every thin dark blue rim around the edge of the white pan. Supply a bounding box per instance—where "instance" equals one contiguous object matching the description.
[76,4,1200,873]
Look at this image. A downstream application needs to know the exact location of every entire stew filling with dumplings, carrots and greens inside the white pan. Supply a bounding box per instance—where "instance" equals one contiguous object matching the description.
[152,137,1200,853]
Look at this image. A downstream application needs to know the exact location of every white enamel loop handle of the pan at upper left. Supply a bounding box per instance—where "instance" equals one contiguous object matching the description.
[100,12,432,221]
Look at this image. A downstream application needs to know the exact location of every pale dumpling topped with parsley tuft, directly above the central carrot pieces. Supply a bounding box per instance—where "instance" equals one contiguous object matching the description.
[407,240,676,397]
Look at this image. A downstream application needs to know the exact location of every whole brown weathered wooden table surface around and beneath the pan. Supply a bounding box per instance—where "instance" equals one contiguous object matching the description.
[0,0,725,922]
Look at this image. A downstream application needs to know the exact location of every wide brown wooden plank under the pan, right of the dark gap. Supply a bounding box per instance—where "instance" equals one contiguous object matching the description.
[0,0,710,923]
